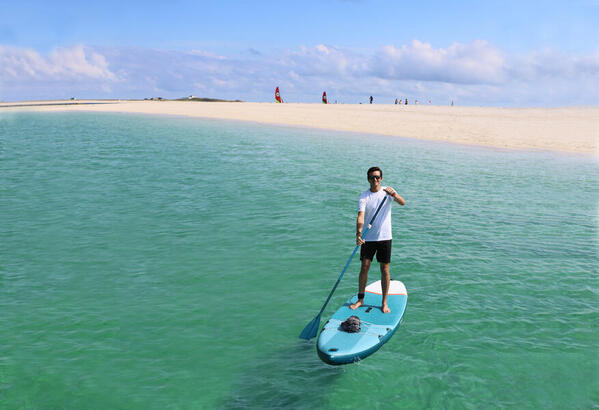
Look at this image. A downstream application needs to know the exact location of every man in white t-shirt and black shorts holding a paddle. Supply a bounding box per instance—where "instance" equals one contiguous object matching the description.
[350,167,406,313]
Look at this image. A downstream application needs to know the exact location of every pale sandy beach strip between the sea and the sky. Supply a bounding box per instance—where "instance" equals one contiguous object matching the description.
[0,100,599,156]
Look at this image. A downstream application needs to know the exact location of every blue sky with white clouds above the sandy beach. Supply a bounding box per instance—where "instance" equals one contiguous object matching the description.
[0,0,599,107]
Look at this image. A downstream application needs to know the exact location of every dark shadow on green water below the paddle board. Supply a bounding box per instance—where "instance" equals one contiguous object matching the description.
[222,340,345,409]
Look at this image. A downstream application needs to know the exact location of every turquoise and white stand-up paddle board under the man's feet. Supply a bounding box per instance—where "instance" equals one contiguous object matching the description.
[316,280,408,365]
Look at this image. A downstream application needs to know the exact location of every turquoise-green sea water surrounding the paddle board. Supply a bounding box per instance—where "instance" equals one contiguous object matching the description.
[0,113,599,409]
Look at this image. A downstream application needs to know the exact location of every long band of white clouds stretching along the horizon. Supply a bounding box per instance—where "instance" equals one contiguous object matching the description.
[0,40,599,105]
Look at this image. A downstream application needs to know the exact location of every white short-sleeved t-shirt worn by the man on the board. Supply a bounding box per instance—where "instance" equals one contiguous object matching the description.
[358,187,393,242]
